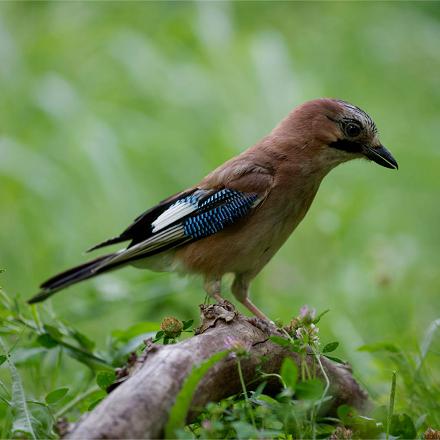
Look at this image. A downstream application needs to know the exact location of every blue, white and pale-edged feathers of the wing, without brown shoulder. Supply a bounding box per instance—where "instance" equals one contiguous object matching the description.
[105,188,265,267]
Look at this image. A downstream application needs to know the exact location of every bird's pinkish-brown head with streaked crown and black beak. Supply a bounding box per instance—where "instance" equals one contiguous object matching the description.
[277,98,398,169]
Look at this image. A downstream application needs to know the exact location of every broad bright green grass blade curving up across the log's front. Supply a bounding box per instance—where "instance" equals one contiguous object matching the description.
[165,350,229,438]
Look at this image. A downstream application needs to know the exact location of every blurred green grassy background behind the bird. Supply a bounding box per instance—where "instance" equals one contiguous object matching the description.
[0,2,440,410]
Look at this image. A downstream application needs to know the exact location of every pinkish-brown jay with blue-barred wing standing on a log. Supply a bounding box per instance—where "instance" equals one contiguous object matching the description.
[28,98,398,320]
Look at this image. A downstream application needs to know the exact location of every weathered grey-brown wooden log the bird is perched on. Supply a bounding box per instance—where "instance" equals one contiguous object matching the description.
[68,302,368,439]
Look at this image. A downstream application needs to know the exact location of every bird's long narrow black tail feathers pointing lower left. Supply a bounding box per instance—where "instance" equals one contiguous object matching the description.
[28,254,115,304]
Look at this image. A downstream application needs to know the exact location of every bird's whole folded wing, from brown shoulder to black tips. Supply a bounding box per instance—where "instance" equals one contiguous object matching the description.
[88,157,273,270]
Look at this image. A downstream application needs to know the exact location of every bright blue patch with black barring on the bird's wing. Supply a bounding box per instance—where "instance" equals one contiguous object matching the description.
[183,189,258,240]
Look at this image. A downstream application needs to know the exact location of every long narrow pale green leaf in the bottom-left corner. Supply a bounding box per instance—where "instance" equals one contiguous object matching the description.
[0,338,36,440]
